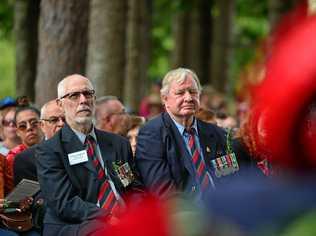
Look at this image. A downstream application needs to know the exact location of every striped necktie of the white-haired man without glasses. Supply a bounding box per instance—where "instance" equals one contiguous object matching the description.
[187,128,211,190]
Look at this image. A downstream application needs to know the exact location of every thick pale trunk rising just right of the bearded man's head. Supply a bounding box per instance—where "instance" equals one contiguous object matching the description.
[87,0,127,98]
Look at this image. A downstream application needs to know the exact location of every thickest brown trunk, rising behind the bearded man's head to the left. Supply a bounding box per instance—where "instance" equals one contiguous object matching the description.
[36,0,89,105]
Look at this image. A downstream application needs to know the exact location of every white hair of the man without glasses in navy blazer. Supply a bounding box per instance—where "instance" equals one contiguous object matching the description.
[160,67,202,95]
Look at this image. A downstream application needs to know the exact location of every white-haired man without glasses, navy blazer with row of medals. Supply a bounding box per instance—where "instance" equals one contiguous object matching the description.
[135,68,254,199]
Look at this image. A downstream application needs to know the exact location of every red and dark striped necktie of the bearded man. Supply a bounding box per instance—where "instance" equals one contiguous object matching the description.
[85,135,119,213]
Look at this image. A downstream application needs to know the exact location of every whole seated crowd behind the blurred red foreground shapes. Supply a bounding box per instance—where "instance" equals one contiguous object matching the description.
[0,57,313,236]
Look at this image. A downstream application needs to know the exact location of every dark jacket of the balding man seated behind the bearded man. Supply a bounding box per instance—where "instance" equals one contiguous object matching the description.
[13,145,37,185]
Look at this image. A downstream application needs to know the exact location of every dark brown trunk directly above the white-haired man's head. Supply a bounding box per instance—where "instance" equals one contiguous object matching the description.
[172,0,211,84]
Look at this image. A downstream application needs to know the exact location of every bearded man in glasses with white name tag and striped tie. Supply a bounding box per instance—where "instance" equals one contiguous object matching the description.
[37,74,143,236]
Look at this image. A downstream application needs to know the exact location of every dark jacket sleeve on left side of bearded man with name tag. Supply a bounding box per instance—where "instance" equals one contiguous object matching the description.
[36,143,108,223]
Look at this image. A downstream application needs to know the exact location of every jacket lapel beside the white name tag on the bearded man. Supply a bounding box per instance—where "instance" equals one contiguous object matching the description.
[62,124,97,174]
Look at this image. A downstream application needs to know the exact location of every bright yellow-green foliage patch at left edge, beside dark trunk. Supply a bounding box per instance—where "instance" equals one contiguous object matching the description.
[0,39,15,98]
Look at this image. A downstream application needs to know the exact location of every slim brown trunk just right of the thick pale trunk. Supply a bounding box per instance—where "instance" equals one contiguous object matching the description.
[124,0,142,112]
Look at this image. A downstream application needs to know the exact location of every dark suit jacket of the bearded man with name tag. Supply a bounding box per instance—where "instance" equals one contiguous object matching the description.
[36,124,142,234]
